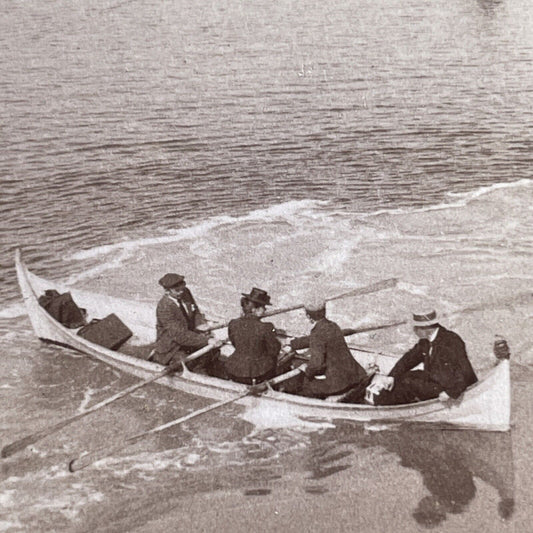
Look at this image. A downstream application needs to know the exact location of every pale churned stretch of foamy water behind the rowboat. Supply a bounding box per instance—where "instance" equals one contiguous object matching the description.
[5,179,533,370]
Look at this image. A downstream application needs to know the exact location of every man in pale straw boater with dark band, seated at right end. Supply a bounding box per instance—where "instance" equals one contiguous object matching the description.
[366,310,477,405]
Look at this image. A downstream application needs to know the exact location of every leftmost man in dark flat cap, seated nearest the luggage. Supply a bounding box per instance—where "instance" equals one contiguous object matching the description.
[150,273,217,370]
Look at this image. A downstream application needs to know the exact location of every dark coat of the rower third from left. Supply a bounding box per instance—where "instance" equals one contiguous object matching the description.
[302,318,367,396]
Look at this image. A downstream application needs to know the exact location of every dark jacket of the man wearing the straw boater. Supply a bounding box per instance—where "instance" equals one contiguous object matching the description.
[389,324,477,398]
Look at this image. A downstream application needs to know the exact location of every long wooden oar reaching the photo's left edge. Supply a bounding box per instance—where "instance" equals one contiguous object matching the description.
[2,345,215,457]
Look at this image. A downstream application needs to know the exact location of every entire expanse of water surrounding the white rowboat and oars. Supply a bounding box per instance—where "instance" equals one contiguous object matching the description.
[0,0,533,533]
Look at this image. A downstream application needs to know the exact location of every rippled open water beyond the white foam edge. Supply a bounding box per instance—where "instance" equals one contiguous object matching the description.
[0,0,533,296]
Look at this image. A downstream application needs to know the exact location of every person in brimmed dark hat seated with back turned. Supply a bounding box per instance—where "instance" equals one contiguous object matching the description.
[226,287,281,385]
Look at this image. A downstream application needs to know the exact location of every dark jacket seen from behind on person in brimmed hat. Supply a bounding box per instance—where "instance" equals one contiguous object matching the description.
[226,315,281,378]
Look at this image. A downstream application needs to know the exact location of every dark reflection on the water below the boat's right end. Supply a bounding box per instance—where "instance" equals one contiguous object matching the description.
[311,423,514,528]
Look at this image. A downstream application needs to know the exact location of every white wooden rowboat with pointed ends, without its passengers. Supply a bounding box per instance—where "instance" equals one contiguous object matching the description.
[15,250,511,431]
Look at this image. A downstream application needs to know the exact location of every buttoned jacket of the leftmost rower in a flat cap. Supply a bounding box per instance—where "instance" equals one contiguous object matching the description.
[155,294,207,354]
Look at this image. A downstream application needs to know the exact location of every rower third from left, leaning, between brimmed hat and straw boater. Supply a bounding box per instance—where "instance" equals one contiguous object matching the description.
[285,298,370,399]
